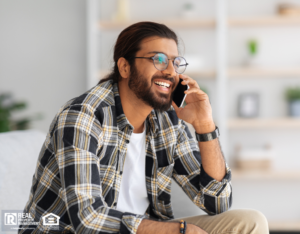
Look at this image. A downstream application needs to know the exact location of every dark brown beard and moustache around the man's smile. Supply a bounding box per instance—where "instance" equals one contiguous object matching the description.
[128,65,175,111]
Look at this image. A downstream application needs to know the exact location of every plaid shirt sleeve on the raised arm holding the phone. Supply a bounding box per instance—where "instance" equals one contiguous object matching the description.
[173,120,232,215]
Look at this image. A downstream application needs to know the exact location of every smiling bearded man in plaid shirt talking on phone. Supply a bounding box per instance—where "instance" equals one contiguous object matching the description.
[19,22,268,234]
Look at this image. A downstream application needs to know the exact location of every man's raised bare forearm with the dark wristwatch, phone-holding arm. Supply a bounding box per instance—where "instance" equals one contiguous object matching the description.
[194,123,226,181]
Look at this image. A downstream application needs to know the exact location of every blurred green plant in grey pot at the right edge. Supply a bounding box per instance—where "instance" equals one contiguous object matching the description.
[285,87,300,117]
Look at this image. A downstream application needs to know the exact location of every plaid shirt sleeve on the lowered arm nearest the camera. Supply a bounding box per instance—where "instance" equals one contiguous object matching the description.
[53,105,146,234]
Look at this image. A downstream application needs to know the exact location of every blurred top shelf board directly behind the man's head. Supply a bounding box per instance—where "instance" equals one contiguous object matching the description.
[99,19,216,30]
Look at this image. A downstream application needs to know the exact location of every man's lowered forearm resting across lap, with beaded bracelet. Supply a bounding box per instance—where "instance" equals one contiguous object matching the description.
[137,219,207,234]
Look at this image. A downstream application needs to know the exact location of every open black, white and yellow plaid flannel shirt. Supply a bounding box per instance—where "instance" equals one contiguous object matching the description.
[19,81,231,234]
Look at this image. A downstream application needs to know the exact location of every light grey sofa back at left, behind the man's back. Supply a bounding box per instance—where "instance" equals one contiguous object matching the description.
[0,130,46,210]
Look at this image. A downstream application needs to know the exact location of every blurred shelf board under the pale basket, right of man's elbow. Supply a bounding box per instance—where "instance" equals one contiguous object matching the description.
[231,169,300,180]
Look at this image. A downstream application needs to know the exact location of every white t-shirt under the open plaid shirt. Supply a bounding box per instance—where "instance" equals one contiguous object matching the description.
[116,123,149,214]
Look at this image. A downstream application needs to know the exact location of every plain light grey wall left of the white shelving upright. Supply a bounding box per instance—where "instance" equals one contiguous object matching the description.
[0,0,86,132]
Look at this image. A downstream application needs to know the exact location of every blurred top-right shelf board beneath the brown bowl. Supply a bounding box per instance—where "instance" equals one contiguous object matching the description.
[228,15,300,27]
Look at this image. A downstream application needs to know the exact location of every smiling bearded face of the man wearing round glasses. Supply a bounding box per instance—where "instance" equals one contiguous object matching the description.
[128,37,179,111]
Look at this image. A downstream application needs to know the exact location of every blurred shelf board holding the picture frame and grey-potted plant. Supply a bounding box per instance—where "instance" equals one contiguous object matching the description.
[228,117,300,129]
